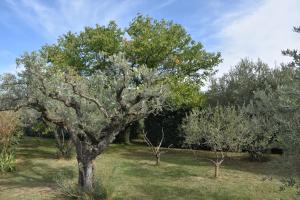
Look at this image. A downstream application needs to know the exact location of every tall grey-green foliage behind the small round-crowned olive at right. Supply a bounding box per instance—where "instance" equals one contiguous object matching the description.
[206,55,298,160]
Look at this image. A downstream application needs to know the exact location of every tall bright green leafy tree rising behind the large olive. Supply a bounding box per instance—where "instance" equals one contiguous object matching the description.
[42,15,221,142]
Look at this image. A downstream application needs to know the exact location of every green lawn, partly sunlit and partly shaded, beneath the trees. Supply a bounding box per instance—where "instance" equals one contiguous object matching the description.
[0,138,299,200]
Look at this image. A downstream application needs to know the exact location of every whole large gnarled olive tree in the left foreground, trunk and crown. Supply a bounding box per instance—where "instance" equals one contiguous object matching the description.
[0,53,167,190]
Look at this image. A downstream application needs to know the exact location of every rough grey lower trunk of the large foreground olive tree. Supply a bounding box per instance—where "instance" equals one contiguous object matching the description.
[78,160,94,191]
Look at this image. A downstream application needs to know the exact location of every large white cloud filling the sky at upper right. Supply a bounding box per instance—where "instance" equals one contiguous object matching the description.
[215,0,300,75]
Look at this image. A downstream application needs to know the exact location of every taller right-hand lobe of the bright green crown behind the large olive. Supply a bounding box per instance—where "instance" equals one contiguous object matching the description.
[125,15,220,80]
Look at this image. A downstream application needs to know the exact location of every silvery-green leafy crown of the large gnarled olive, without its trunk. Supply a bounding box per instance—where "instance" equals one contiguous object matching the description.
[7,53,168,142]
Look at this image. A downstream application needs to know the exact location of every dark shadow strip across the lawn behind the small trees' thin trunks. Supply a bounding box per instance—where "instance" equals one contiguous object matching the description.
[120,147,290,177]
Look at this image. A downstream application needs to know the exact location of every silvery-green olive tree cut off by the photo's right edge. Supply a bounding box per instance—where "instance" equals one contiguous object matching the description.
[267,27,300,195]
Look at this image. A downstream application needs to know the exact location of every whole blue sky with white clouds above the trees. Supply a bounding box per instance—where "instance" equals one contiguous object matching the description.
[0,0,300,74]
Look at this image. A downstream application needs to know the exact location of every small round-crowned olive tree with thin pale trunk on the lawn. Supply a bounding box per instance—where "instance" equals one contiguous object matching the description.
[182,106,248,178]
